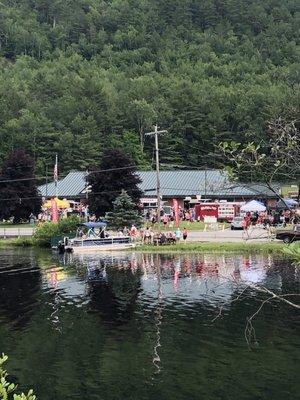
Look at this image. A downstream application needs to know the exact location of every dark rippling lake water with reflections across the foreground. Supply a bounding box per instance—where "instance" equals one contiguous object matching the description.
[0,249,300,400]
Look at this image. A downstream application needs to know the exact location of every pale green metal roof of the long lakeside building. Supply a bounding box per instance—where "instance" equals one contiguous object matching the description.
[39,170,279,198]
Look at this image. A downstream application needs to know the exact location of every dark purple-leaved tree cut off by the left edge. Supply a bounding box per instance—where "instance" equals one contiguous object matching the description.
[0,150,41,222]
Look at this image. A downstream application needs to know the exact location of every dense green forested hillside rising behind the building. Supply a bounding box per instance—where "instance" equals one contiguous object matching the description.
[0,0,300,174]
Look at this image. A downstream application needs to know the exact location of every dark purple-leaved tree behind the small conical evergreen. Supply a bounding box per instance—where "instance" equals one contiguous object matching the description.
[87,149,142,217]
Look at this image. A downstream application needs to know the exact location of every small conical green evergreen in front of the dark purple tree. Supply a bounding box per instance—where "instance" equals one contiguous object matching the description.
[107,190,142,229]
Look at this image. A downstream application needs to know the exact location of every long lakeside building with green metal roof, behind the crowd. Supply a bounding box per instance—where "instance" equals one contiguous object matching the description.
[39,170,280,207]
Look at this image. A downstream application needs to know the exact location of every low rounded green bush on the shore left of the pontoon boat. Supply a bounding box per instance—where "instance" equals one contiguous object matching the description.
[33,216,82,247]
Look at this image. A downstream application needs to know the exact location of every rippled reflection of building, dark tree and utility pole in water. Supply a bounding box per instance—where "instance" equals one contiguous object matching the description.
[49,253,281,375]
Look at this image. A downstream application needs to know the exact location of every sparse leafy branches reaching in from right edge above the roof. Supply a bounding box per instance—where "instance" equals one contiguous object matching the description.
[219,109,300,187]
